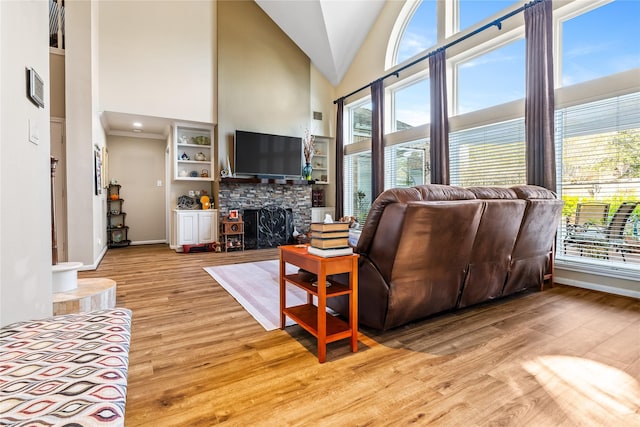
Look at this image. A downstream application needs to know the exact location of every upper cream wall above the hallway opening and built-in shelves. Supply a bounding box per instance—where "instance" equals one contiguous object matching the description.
[98,1,216,123]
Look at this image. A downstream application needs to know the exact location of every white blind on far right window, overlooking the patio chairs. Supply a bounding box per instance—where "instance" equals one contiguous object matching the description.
[556,93,640,271]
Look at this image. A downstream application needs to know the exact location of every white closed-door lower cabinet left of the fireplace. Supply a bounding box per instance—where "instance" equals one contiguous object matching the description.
[174,209,218,246]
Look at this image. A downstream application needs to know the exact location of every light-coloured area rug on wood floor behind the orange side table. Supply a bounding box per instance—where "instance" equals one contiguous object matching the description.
[204,260,307,331]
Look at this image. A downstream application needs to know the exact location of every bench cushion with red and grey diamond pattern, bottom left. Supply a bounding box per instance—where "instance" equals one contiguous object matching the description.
[0,308,131,427]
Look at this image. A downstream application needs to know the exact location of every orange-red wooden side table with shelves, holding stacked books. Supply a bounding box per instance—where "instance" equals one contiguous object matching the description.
[280,245,359,363]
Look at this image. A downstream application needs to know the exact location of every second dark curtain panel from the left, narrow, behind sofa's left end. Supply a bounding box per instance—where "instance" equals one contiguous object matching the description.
[371,79,384,200]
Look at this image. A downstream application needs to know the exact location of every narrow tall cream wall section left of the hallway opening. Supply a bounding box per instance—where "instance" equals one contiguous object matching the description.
[65,1,106,267]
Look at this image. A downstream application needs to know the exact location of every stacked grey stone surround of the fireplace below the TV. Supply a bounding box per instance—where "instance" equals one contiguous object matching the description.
[218,179,311,239]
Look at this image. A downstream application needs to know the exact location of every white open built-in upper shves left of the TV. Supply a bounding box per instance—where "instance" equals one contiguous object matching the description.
[173,123,215,181]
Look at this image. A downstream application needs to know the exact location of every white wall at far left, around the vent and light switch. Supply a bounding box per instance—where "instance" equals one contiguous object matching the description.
[0,0,52,326]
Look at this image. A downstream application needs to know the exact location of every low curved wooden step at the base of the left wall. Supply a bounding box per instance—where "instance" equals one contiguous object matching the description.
[53,278,116,316]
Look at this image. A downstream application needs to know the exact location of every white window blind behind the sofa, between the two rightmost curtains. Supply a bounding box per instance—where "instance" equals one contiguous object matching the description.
[449,119,526,187]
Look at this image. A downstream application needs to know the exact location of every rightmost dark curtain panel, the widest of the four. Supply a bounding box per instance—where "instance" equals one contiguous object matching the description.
[524,0,556,191]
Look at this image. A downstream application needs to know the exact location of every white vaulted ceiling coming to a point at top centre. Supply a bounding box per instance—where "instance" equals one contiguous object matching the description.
[256,0,385,86]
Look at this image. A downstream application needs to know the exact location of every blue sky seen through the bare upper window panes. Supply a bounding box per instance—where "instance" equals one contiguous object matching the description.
[397,0,640,120]
